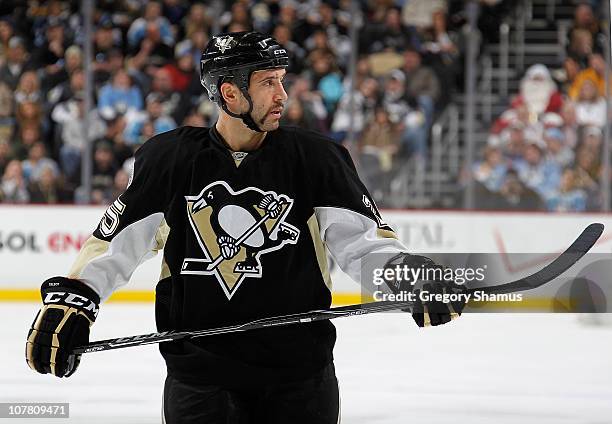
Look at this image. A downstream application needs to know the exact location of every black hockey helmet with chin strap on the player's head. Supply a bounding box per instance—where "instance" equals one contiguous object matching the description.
[200,31,289,132]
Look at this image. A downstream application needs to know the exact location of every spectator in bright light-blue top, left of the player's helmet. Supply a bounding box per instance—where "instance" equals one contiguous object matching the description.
[98,69,143,116]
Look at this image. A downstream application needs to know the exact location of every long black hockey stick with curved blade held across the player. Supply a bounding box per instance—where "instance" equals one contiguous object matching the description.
[73,223,604,354]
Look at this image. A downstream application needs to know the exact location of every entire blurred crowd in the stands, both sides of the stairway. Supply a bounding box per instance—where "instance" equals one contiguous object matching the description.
[0,0,608,211]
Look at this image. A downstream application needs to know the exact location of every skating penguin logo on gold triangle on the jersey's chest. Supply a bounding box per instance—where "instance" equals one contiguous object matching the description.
[181,181,300,299]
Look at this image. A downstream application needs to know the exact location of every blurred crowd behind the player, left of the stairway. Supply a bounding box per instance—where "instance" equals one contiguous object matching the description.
[0,0,512,203]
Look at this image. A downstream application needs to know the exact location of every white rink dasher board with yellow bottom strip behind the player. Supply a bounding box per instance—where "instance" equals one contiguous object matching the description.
[0,205,612,296]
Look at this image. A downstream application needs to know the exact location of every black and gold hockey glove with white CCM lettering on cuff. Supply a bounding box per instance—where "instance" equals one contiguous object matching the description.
[26,277,100,377]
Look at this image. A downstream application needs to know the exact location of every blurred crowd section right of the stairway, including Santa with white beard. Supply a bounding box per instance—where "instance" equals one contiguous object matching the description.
[472,2,609,212]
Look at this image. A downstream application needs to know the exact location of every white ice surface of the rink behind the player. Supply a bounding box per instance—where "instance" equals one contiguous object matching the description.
[0,303,612,424]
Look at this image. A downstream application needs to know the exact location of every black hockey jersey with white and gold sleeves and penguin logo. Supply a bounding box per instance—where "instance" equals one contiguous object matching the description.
[69,127,405,387]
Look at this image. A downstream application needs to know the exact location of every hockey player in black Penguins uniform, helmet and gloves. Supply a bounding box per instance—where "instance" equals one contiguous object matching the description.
[26,32,464,424]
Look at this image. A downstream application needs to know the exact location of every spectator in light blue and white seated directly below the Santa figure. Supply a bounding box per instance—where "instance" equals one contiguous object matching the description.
[513,138,561,198]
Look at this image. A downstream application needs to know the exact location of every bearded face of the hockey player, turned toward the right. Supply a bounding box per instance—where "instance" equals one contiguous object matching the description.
[249,69,287,131]
